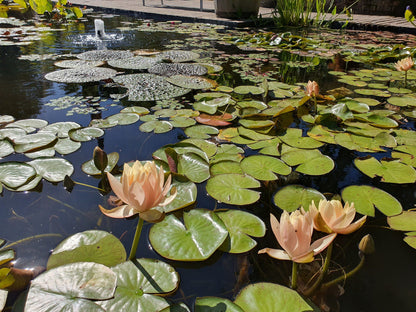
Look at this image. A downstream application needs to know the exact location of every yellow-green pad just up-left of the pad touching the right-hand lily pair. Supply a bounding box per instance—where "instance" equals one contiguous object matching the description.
[240,155,292,181]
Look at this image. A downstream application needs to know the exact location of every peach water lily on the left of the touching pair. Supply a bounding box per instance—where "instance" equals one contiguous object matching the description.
[258,210,337,263]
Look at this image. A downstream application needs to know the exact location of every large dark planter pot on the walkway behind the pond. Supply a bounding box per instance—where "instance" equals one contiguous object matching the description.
[214,0,260,19]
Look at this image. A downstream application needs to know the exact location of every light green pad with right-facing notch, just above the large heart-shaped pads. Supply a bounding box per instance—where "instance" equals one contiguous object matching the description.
[206,174,260,205]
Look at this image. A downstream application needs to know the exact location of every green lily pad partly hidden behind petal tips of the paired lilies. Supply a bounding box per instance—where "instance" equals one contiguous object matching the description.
[273,185,325,212]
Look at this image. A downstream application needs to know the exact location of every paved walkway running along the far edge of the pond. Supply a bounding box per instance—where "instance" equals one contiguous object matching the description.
[71,0,416,34]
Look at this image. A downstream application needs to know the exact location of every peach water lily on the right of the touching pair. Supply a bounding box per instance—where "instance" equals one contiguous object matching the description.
[309,200,367,234]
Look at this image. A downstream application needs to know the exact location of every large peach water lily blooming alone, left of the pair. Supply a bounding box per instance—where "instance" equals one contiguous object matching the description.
[100,161,176,219]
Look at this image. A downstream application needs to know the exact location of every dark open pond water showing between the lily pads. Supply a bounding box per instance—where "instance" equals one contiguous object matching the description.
[0,9,416,312]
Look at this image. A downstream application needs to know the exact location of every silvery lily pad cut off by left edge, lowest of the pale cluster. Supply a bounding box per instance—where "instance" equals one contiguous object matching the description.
[0,161,36,189]
